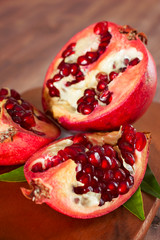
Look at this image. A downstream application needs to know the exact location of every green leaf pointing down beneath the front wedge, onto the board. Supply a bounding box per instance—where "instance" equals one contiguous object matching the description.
[123,187,145,221]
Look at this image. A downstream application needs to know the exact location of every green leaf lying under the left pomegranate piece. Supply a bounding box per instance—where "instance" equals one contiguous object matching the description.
[0,166,26,182]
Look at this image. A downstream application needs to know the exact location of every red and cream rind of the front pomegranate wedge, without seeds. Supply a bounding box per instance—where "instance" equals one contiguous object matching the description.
[22,132,151,219]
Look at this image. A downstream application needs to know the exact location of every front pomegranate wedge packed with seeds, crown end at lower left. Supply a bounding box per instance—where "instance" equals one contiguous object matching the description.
[22,125,150,218]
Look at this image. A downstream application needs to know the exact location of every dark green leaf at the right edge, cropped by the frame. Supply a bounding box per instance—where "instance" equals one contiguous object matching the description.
[141,165,160,198]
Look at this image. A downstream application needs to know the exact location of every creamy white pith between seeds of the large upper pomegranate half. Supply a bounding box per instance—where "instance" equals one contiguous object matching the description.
[47,31,143,118]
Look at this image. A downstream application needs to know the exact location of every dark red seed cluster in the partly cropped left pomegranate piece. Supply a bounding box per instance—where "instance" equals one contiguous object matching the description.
[0,88,49,135]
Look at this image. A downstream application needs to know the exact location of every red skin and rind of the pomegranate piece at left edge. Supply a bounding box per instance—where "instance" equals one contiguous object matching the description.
[0,88,60,165]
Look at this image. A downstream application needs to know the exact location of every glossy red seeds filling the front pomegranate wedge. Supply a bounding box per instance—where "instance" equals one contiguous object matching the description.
[31,124,146,206]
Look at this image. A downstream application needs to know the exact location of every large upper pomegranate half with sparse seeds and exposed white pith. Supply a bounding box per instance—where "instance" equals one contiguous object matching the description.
[42,21,157,131]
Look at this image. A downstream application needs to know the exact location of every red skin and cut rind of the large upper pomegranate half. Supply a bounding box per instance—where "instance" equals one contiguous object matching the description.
[42,22,157,131]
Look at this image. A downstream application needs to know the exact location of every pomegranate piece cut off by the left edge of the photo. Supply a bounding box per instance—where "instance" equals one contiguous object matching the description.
[0,88,60,165]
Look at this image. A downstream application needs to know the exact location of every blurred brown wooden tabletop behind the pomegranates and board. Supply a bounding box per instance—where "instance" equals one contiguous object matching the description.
[0,0,160,240]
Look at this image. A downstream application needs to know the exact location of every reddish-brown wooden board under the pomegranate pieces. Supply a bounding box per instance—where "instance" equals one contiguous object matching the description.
[0,88,160,240]
